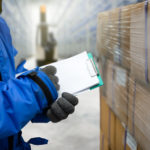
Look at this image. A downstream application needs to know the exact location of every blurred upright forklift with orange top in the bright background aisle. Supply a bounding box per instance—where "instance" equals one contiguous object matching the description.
[36,5,57,66]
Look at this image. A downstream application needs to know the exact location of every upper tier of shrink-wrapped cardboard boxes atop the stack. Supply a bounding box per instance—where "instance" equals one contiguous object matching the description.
[97,2,150,82]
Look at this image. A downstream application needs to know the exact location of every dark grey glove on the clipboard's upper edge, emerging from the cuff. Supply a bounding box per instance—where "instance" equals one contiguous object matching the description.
[41,66,60,91]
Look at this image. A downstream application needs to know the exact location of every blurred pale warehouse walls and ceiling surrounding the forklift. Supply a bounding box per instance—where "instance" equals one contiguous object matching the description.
[0,0,141,60]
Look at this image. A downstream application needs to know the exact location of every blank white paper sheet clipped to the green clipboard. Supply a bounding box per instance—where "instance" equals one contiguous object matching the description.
[41,52,99,95]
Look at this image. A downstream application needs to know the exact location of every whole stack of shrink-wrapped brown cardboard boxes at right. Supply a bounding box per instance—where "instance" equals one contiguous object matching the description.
[97,1,150,150]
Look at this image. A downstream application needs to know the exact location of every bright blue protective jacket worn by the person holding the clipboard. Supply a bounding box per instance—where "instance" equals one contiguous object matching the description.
[0,17,58,150]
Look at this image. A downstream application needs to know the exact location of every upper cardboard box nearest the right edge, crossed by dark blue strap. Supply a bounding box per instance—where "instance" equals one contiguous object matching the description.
[130,2,150,82]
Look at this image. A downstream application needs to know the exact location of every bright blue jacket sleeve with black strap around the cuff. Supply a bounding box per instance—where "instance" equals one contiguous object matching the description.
[0,71,58,138]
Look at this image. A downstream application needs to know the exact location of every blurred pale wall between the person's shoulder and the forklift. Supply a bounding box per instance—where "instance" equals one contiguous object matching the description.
[2,0,34,60]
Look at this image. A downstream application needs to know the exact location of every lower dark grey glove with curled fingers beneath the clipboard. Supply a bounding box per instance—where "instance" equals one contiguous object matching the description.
[47,93,78,123]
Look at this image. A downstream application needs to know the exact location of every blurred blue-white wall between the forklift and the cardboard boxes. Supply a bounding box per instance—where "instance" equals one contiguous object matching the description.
[56,0,137,57]
